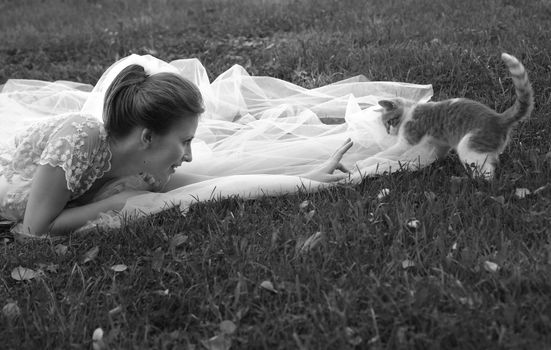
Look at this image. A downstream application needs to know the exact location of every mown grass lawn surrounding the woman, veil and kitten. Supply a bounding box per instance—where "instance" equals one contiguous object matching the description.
[0,0,551,349]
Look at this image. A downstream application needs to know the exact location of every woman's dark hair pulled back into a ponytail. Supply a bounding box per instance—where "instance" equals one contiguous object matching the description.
[103,64,205,138]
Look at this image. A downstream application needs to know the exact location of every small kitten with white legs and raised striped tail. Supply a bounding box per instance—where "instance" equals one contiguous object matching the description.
[379,53,534,179]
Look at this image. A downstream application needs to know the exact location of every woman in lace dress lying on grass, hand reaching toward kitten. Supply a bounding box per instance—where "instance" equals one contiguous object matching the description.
[0,64,352,236]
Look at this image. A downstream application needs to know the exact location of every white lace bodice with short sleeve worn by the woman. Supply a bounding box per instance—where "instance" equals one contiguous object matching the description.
[0,113,111,221]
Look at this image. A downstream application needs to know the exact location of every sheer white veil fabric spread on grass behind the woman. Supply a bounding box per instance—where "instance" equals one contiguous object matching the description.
[0,55,435,231]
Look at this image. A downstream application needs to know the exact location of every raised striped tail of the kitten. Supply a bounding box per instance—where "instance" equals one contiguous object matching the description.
[501,53,534,125]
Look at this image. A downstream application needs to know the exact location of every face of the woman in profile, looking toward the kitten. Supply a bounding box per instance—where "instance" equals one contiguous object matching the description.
[144,116,199,184]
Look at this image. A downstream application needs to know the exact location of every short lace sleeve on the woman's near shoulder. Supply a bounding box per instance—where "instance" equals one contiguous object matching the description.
[38,116,108,196]
